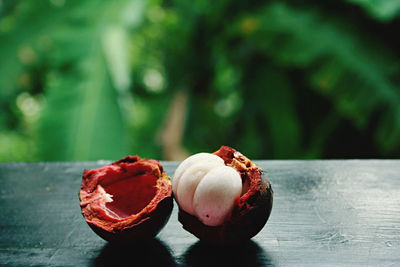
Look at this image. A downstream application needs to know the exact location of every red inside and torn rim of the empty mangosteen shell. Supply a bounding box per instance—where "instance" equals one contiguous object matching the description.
[79,156,172,232]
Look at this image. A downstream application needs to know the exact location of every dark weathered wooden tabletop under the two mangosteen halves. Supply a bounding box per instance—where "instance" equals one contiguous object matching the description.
[0,160,400,266]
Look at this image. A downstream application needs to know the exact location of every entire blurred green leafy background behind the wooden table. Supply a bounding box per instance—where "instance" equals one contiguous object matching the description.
[0,0,400,162]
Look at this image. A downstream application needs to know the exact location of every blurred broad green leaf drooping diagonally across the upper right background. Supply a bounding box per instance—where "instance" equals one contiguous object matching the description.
[234,3,400,151]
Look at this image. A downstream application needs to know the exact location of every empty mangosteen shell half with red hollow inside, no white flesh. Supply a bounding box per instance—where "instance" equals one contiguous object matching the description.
[79,156,173,243]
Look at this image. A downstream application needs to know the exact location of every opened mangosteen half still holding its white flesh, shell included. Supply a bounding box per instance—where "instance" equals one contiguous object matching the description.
[172,146,273,243]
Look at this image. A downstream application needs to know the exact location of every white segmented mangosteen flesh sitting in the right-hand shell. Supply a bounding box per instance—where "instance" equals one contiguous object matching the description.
[172,153,242,226]
